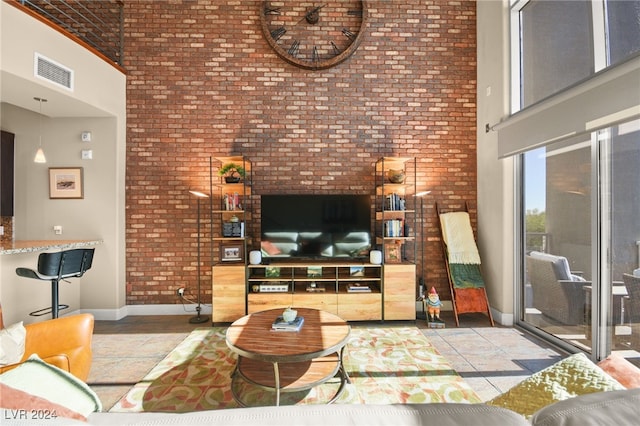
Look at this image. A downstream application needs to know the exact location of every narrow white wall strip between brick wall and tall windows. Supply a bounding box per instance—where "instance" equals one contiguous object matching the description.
[476,0,515,325]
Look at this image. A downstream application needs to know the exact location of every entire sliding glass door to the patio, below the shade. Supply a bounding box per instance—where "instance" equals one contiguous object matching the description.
[520,120,640,362]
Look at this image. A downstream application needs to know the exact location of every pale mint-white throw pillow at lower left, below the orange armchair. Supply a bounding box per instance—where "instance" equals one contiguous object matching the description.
[0,354,102,417]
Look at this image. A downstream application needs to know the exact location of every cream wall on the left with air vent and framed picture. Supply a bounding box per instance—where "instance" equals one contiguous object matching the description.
[0,2,126,322]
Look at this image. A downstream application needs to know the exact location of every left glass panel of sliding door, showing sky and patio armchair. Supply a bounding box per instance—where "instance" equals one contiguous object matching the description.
[522,139,594,348]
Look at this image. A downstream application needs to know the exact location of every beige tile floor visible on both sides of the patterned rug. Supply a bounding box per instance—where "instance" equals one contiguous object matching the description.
[88,312,566,410]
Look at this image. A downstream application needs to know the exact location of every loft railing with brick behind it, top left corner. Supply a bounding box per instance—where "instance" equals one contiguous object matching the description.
[16,0,124,66]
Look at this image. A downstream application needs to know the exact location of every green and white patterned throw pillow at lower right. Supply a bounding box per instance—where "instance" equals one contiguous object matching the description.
[487,353,625,418]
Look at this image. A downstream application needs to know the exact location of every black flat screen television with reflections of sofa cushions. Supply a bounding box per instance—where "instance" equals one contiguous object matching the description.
[260,194,371,260]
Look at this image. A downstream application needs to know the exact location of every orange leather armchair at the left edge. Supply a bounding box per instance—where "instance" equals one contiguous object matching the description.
[0,307,94,382]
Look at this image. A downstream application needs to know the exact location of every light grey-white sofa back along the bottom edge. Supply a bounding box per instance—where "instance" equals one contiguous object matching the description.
[5,389,640,426]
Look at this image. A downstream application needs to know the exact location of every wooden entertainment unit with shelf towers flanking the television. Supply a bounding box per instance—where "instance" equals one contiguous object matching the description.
[212,157,416,323]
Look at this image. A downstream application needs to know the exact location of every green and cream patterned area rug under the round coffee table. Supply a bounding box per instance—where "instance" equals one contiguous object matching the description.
[110,326,481,412]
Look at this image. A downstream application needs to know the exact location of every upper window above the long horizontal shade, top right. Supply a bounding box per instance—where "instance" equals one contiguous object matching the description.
[514,0,640,108]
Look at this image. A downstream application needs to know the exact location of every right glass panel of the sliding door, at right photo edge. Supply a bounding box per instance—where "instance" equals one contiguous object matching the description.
[604,120,640,356]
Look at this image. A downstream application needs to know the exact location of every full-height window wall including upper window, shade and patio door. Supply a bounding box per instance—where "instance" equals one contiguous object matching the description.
[510,0,640,359]
